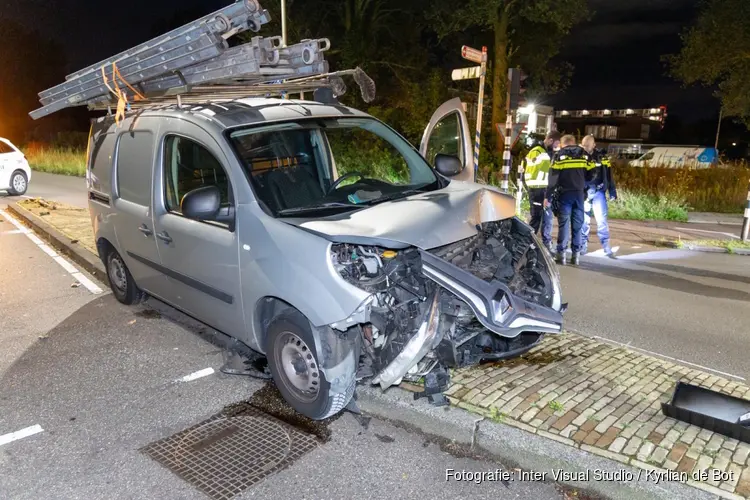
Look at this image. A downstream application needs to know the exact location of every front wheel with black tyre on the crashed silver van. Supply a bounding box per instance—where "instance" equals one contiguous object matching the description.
[266,311,356,420]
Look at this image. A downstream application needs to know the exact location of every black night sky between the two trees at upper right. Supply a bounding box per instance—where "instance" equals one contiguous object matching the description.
[549,0,719,120]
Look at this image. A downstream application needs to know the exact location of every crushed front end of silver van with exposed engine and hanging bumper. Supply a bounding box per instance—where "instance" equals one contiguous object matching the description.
[312,189,565,392]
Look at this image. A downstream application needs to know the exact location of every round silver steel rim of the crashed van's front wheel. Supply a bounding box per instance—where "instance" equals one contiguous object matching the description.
[280,332,320,401]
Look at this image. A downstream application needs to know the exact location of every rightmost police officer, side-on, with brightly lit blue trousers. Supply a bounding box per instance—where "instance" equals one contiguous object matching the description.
[581,135,617,259]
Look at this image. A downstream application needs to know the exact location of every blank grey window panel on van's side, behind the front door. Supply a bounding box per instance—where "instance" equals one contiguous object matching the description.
[117,131,154,207]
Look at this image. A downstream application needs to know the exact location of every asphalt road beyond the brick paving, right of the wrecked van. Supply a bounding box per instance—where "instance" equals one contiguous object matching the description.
[560,249,750,380]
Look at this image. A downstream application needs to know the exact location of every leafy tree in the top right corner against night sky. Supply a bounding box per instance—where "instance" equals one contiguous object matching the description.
[667,0,750,128]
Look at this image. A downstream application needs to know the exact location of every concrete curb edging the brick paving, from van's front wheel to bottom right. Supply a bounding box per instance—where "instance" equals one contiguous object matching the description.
[357,386,724,500]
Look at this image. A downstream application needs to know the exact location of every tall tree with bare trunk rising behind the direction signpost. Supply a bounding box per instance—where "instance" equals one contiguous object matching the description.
[427,0,589,147]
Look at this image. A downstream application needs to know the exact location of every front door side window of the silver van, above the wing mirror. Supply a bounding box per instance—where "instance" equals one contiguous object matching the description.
[164,135,230,213]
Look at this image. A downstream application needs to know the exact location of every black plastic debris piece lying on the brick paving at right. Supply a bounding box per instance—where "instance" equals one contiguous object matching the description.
[661,382,750,443]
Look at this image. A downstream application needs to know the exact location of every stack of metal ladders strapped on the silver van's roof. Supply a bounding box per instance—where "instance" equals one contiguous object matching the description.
[29,0,375,120]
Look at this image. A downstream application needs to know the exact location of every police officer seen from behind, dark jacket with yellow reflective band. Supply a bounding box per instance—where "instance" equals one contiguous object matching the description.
[544,135,596,266]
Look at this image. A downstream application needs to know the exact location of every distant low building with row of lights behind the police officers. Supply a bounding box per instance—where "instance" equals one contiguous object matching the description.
[555,106,667,144]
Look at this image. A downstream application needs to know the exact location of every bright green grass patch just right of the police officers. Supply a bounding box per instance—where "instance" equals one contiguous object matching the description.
[609,191,688,222]
